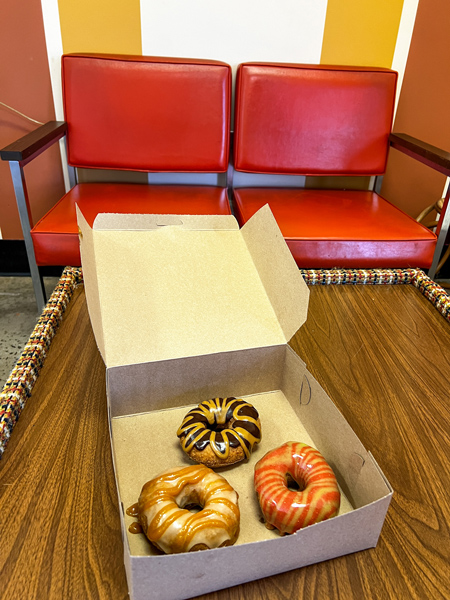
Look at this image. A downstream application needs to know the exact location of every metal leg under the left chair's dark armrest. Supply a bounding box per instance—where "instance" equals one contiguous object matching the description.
[9,161,46,313]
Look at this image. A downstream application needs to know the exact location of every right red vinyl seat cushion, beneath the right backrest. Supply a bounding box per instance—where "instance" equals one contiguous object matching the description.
[235,188,436,268]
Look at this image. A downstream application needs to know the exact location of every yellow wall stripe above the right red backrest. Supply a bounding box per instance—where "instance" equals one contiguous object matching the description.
[320,0,403,68]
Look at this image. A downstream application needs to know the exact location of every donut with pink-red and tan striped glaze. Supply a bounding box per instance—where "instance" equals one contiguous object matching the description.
[254,442,341,535]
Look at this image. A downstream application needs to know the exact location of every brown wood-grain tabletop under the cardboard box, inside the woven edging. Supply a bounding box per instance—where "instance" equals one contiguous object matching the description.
[0,285,450,600]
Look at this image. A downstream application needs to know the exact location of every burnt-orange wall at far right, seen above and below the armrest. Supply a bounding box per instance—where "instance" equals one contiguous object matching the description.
[382,0,450,217]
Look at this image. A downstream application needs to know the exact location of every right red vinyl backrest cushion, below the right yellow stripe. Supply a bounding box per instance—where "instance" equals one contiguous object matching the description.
[235,63,397,175]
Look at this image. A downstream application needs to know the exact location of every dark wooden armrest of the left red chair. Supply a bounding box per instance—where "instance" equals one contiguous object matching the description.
[0,121,67,164]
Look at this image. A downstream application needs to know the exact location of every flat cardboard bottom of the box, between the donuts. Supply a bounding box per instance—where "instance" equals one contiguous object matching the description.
[112,391,352,556]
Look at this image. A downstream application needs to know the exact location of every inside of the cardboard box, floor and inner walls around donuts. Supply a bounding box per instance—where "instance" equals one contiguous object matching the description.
[108,346,390,556]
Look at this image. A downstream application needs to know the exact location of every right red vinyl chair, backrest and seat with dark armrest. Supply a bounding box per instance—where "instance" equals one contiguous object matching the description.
[233,63,450,276]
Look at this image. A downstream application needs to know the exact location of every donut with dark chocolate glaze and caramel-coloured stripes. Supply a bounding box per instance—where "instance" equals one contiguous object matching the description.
[177,398,261,468]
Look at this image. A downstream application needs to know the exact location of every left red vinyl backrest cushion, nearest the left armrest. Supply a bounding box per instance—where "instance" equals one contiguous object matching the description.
[62,54,231,172]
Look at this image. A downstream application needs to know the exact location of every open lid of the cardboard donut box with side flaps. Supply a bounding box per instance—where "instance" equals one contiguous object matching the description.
[77,207,309,367]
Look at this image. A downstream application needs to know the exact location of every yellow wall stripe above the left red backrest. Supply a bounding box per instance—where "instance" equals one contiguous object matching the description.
[58,0,142,54]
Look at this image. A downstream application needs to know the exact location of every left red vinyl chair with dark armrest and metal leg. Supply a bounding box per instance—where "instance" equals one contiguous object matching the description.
[1,54,231,310]
